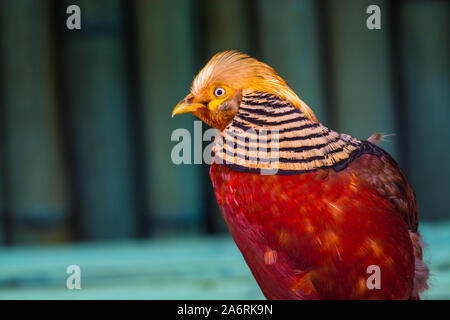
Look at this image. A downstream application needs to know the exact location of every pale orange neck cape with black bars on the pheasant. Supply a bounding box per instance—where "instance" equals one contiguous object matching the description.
[213,91,381,175]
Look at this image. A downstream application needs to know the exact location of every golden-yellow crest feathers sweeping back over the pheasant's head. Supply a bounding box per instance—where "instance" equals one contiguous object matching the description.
[191,50,317,122]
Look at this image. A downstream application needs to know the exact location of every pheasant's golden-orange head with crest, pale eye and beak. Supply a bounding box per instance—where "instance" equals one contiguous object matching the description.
[172,51,317,131]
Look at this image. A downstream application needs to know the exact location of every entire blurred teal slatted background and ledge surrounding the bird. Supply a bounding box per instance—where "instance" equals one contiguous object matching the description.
[0,0,450,299]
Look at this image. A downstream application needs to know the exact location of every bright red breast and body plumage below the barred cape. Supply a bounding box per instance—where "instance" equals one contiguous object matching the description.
[210,154,415,299]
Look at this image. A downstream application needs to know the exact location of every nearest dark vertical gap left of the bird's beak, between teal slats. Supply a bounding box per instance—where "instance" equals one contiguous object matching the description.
[122,0,152,238]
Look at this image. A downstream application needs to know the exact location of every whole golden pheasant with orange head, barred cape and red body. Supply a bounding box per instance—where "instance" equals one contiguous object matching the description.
[172,51,428,299]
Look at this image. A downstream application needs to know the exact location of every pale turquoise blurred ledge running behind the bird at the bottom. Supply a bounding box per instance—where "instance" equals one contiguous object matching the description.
[0,222,450,300]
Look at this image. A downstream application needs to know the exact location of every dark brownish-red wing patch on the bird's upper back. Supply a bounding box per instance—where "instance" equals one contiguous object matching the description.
[349,147,419,232]
